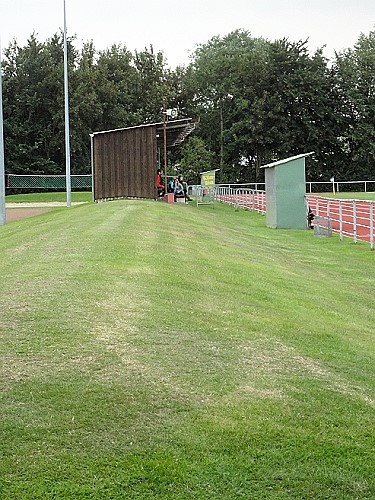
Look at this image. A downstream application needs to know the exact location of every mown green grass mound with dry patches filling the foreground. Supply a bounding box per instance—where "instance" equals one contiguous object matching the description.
[0,200,375,500]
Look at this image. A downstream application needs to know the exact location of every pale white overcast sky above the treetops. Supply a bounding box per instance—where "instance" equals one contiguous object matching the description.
[0,0,375,67]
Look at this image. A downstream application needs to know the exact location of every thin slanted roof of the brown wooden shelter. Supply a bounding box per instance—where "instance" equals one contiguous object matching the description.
[92,118,196,148]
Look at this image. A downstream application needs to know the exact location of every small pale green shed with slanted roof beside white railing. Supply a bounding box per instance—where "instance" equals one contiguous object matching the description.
[261,153,313,229]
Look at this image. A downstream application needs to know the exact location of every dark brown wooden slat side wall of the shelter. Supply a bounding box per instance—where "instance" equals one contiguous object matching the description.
[94,126,157,200]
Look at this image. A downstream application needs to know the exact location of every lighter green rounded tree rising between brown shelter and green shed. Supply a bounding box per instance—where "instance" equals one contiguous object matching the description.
[192,30,267,176]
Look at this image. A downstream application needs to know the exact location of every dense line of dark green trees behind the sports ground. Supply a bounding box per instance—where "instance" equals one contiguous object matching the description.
[2,30,375,182]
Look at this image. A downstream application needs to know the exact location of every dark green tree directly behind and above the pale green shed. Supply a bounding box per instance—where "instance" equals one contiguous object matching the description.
[263,39,342,182]
